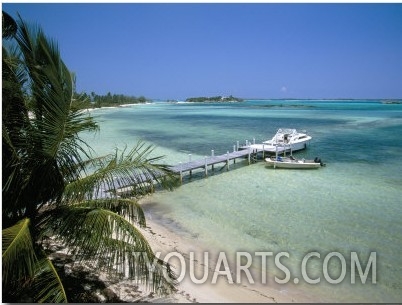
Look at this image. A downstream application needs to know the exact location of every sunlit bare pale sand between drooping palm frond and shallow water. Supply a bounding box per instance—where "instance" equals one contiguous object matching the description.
[142,199,319,303]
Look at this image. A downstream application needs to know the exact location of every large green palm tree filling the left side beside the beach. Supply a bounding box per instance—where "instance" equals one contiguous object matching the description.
[2,12,176,302]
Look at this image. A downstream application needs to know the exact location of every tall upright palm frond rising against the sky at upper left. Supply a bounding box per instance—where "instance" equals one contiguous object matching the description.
[16,14,97,160]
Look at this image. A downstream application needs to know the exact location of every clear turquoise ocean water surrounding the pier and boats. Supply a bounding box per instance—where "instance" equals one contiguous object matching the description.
[82,100,402,302]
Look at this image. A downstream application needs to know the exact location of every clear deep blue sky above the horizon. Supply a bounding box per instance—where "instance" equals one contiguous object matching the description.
[2,3,402,99]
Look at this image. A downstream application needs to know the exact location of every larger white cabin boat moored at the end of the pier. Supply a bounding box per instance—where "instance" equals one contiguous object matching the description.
[239,128,312,154]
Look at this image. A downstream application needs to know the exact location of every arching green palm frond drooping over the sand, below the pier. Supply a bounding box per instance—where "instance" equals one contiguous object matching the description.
[41,204,175,292]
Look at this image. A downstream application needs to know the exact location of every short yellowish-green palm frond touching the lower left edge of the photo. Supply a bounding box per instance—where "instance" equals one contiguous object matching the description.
[2,218,38,283]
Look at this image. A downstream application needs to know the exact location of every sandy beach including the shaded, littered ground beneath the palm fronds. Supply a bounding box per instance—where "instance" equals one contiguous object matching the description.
[44,185,325,303]
